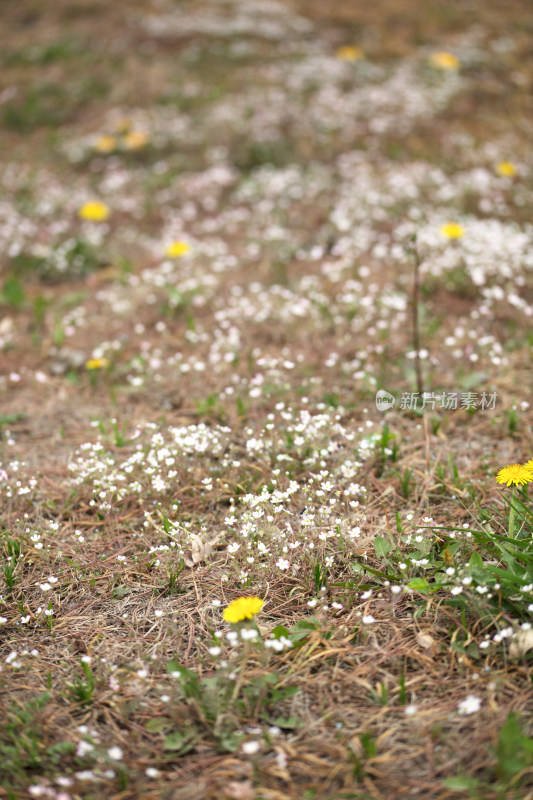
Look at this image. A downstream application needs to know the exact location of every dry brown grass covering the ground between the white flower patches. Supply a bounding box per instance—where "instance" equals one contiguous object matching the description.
[0,0,533,800]
